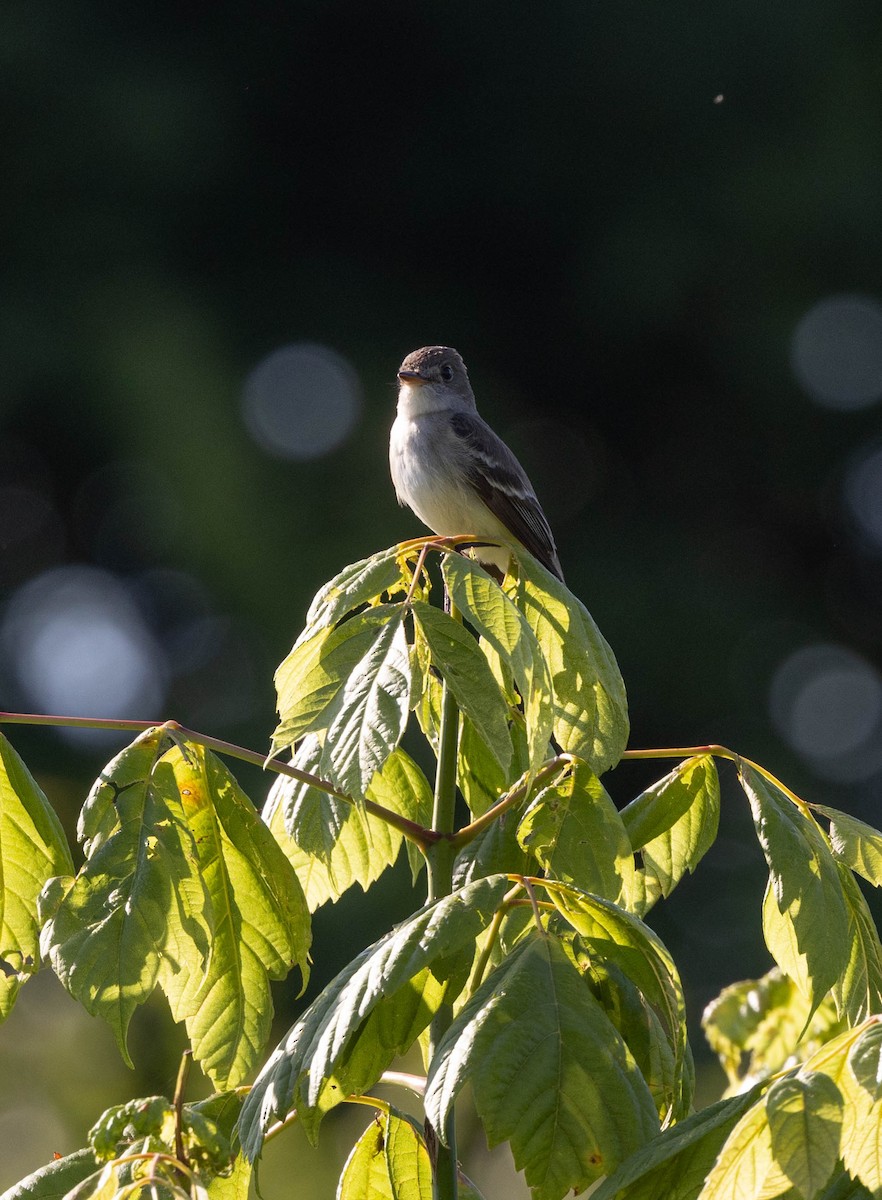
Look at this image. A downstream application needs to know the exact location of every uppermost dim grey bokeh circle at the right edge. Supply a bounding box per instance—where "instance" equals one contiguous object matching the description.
[791,294,882,410]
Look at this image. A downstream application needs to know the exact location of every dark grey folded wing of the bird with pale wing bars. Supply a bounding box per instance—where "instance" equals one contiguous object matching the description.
[450,413,564,583]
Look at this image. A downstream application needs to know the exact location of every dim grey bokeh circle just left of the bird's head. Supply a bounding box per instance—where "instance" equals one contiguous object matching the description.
[242,342,362,461]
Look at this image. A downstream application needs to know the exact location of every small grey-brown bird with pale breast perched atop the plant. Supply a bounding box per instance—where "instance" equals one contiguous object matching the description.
[389,346,564,582]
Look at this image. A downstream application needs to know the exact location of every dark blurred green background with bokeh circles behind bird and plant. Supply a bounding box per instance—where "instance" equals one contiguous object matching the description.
[0,0,882,1195]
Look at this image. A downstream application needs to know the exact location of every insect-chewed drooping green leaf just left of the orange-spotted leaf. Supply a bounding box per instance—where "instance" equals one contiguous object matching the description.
[41,730,211,1064]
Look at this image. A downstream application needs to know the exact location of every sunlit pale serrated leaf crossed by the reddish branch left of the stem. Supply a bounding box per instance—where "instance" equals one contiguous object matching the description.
[263,734,432,911]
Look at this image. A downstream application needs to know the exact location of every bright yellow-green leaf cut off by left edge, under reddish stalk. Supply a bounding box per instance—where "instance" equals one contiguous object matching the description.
[0,733,73,1020]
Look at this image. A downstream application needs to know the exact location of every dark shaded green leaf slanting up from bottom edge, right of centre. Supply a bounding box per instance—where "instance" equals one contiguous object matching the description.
[592,1088,762,1200]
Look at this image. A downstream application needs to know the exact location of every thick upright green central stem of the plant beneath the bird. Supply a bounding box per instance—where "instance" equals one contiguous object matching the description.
[426,602,460,1200]
